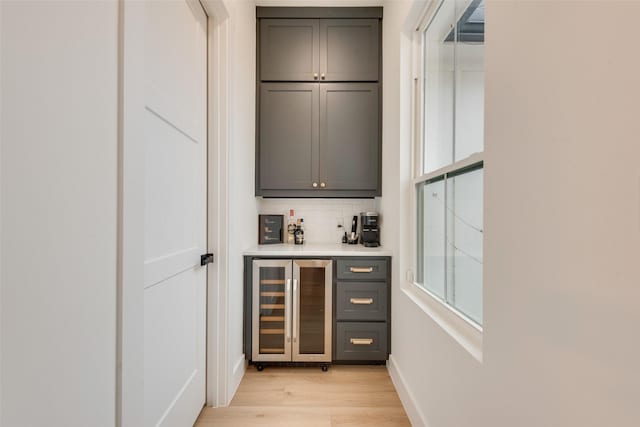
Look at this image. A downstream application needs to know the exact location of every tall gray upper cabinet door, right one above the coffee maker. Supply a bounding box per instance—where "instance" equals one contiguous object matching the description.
[319,83,380,194]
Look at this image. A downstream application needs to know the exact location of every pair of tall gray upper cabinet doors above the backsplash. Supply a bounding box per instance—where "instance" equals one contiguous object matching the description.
[256,83,381,197]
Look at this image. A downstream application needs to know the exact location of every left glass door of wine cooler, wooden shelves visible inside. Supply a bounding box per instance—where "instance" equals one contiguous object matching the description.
[251,260,292,361]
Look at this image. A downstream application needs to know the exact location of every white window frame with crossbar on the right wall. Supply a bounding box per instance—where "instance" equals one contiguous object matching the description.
[403,0,485,362]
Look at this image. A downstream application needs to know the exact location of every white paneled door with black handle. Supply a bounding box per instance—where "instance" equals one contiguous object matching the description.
[144,0,207,427]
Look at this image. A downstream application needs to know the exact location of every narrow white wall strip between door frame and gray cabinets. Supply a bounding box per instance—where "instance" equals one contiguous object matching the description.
[225,0,258,400]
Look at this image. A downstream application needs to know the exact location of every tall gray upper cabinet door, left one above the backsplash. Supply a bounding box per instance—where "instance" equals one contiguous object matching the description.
[257,83,319,191]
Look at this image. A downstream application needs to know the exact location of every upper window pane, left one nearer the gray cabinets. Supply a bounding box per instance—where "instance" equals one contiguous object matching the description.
[422,1,456,173]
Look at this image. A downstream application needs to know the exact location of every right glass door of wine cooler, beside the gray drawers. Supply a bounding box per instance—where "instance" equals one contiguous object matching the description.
[291,260,332,362]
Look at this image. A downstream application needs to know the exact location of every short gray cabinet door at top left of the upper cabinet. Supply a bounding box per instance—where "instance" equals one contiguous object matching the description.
[258,19,320,81]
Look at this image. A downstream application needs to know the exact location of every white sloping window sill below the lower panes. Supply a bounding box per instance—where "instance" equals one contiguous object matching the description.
[402,282,482,363]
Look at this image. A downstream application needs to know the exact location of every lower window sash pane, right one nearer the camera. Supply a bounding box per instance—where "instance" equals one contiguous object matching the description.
[447,169,484,324]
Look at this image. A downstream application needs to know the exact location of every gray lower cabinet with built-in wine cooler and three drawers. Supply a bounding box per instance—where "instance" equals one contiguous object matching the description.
[244,256,391,368]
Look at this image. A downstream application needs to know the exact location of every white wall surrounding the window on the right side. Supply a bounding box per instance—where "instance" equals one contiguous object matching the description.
[383,1,640,427]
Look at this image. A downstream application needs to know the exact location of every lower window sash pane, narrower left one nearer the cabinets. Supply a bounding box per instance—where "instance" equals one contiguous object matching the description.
[418,181,446,299]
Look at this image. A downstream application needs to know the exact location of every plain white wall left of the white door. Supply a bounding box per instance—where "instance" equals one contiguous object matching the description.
[0,1,118,427]
